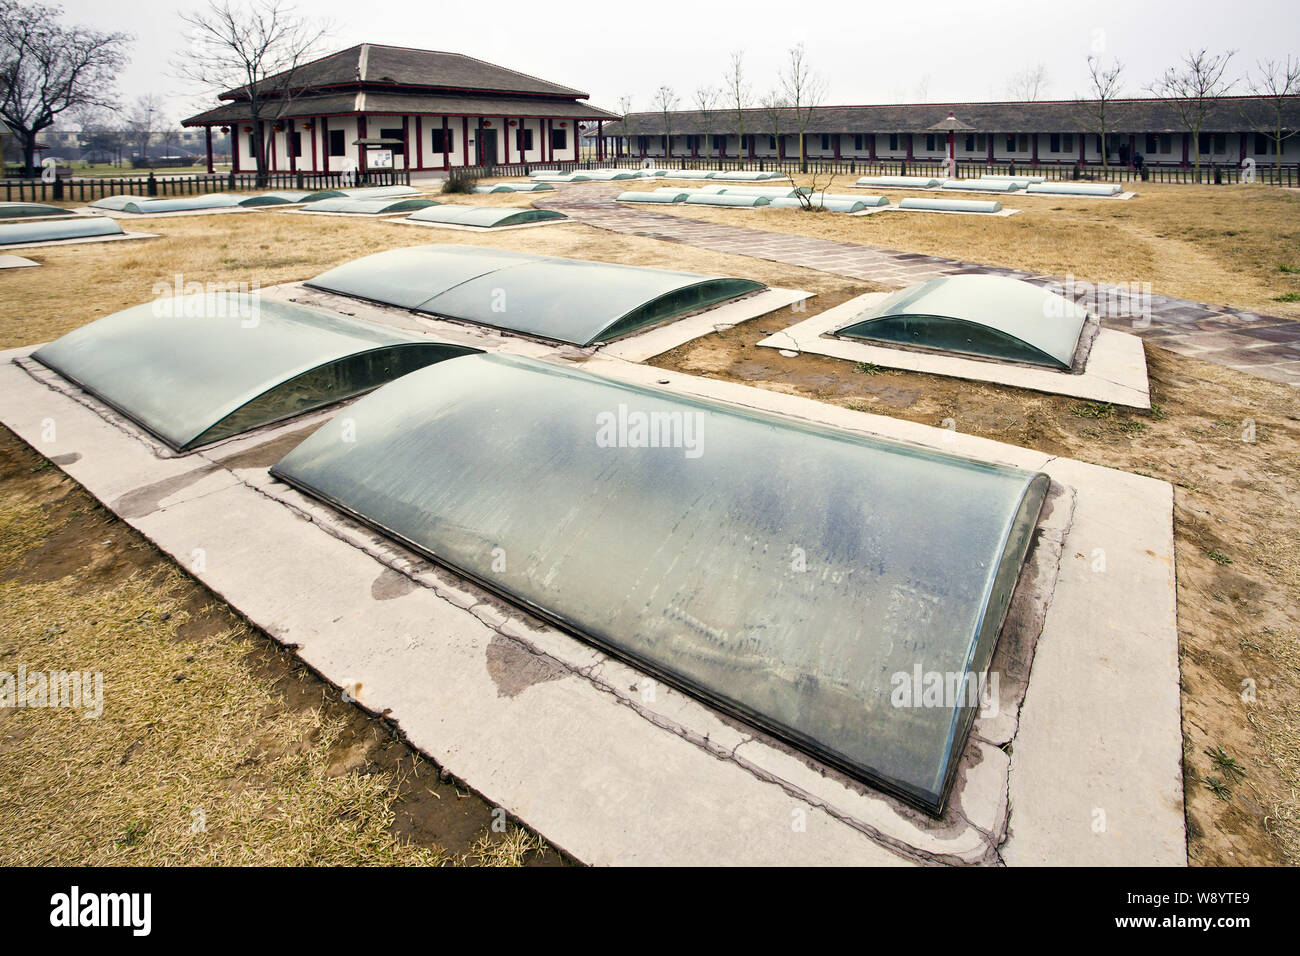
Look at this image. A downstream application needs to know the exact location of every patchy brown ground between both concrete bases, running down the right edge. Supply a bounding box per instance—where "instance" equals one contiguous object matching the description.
[654,312,1300,865]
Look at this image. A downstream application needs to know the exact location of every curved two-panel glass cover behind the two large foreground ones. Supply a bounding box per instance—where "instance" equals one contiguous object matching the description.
[307,246,766,346]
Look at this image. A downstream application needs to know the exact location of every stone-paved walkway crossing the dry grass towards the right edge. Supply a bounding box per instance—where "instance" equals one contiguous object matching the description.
[534,183,1300,385]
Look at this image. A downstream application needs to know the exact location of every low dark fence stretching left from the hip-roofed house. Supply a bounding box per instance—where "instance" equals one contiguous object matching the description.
[0,169,411,203]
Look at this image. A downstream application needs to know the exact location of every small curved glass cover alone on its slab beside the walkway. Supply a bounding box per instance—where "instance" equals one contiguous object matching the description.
[836,276,1088,369]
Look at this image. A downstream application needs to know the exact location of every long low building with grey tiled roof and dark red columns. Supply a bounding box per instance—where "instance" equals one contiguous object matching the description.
[603,96,1300,166]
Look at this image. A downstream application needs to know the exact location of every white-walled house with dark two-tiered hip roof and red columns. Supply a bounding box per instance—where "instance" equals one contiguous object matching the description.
[182,43,618,172]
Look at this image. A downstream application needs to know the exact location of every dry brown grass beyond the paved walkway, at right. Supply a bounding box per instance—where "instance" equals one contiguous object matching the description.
[654,176,1300,317]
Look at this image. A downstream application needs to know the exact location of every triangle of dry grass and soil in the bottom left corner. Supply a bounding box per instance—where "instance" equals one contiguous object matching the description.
[0,429,568,865]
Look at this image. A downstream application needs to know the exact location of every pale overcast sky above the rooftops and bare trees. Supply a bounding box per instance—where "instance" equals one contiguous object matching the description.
[50,0,1300,118]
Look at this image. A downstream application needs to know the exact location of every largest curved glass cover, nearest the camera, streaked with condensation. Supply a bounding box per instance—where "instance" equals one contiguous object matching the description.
[272,354,1048,813]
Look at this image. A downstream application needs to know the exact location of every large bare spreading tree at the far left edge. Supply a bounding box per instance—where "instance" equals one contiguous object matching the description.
[0,0,131,176]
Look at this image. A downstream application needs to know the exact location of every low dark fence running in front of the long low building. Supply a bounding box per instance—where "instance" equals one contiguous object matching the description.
[473,156,1300,187]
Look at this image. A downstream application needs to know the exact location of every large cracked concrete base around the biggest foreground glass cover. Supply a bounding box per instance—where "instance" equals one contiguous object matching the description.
[0,329,1186,865]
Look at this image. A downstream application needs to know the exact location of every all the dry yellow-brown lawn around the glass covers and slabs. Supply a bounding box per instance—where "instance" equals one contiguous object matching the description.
[0,183,1300,865]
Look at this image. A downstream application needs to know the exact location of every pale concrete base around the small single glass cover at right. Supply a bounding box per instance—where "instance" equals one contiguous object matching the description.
[758,293,1151,408]
